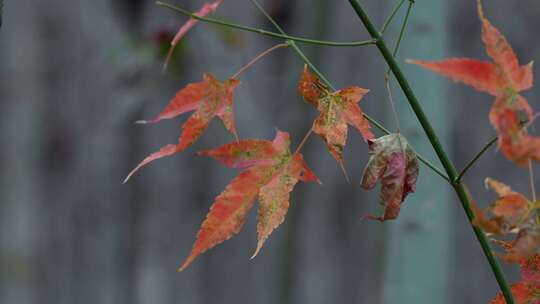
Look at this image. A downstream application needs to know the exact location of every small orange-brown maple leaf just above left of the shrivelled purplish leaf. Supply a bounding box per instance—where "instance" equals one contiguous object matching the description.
[298,66,374,164]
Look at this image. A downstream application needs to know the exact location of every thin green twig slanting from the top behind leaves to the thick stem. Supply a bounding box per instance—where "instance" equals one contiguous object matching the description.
[250,0,450,182]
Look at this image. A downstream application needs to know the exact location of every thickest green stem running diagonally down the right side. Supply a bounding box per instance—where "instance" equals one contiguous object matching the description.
[349,0,515,304]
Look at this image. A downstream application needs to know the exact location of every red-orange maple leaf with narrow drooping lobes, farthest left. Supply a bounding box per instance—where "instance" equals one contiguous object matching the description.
[124,74,240,183]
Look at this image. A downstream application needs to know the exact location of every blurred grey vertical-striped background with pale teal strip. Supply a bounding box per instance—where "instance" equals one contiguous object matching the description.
[0,0,540,304]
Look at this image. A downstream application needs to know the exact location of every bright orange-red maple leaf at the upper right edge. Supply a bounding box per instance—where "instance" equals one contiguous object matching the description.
[408,0,540,165]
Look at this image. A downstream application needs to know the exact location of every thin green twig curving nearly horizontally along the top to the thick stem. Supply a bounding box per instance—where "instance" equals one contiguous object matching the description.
[156,1,375,47]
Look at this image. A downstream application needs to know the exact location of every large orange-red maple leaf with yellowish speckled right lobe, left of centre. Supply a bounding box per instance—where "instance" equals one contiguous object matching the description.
[179,131,319,271]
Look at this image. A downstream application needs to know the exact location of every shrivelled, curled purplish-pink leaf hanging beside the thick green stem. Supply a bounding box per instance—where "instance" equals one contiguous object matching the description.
[361,133,419,222]
